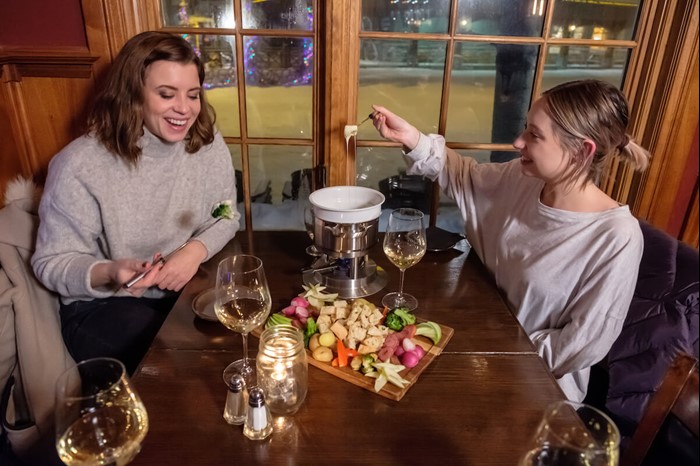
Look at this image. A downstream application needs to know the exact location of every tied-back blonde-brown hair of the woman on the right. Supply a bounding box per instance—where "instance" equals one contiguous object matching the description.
[542,79,649,183]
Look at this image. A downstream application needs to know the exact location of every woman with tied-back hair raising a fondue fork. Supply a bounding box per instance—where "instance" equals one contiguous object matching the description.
[373,80,649,401]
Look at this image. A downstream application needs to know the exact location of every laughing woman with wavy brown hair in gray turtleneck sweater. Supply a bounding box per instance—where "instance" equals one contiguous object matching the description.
[32,32,240,372]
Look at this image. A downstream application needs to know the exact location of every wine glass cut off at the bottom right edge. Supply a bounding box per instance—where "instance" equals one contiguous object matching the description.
[520,401,620,466]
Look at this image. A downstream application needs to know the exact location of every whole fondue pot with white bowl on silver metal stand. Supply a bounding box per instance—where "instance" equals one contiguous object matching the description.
[304,186,387,299]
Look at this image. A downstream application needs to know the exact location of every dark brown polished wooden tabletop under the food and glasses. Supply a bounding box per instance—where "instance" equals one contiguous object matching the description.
[132,232,564,466]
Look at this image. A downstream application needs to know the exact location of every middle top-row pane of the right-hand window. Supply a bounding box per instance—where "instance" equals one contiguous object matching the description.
[457,0,546,37]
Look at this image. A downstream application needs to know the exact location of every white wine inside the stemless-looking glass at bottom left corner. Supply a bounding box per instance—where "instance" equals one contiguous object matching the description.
[56,403,148,466]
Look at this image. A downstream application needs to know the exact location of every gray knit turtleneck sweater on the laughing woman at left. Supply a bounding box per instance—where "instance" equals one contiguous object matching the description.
[32,128,240,304]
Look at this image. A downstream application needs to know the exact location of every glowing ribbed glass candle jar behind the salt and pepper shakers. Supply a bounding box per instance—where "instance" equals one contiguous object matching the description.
[256,325,309,415]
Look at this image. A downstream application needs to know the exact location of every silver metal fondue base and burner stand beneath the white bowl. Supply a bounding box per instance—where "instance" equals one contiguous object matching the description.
[302,217,388,299]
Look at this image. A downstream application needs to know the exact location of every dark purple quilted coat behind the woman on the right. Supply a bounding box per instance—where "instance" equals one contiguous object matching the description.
[605,221,699,426]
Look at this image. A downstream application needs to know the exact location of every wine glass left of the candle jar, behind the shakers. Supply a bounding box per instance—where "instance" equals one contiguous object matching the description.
[214,254,272,386]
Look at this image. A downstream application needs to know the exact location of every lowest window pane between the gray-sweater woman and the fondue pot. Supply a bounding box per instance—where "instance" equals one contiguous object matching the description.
[234,145,313,230]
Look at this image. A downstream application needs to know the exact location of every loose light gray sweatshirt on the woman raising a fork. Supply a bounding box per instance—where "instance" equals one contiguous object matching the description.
[406,134,644,401]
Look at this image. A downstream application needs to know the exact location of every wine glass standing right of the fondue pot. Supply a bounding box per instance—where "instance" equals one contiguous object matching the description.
[382,208,426,310]
